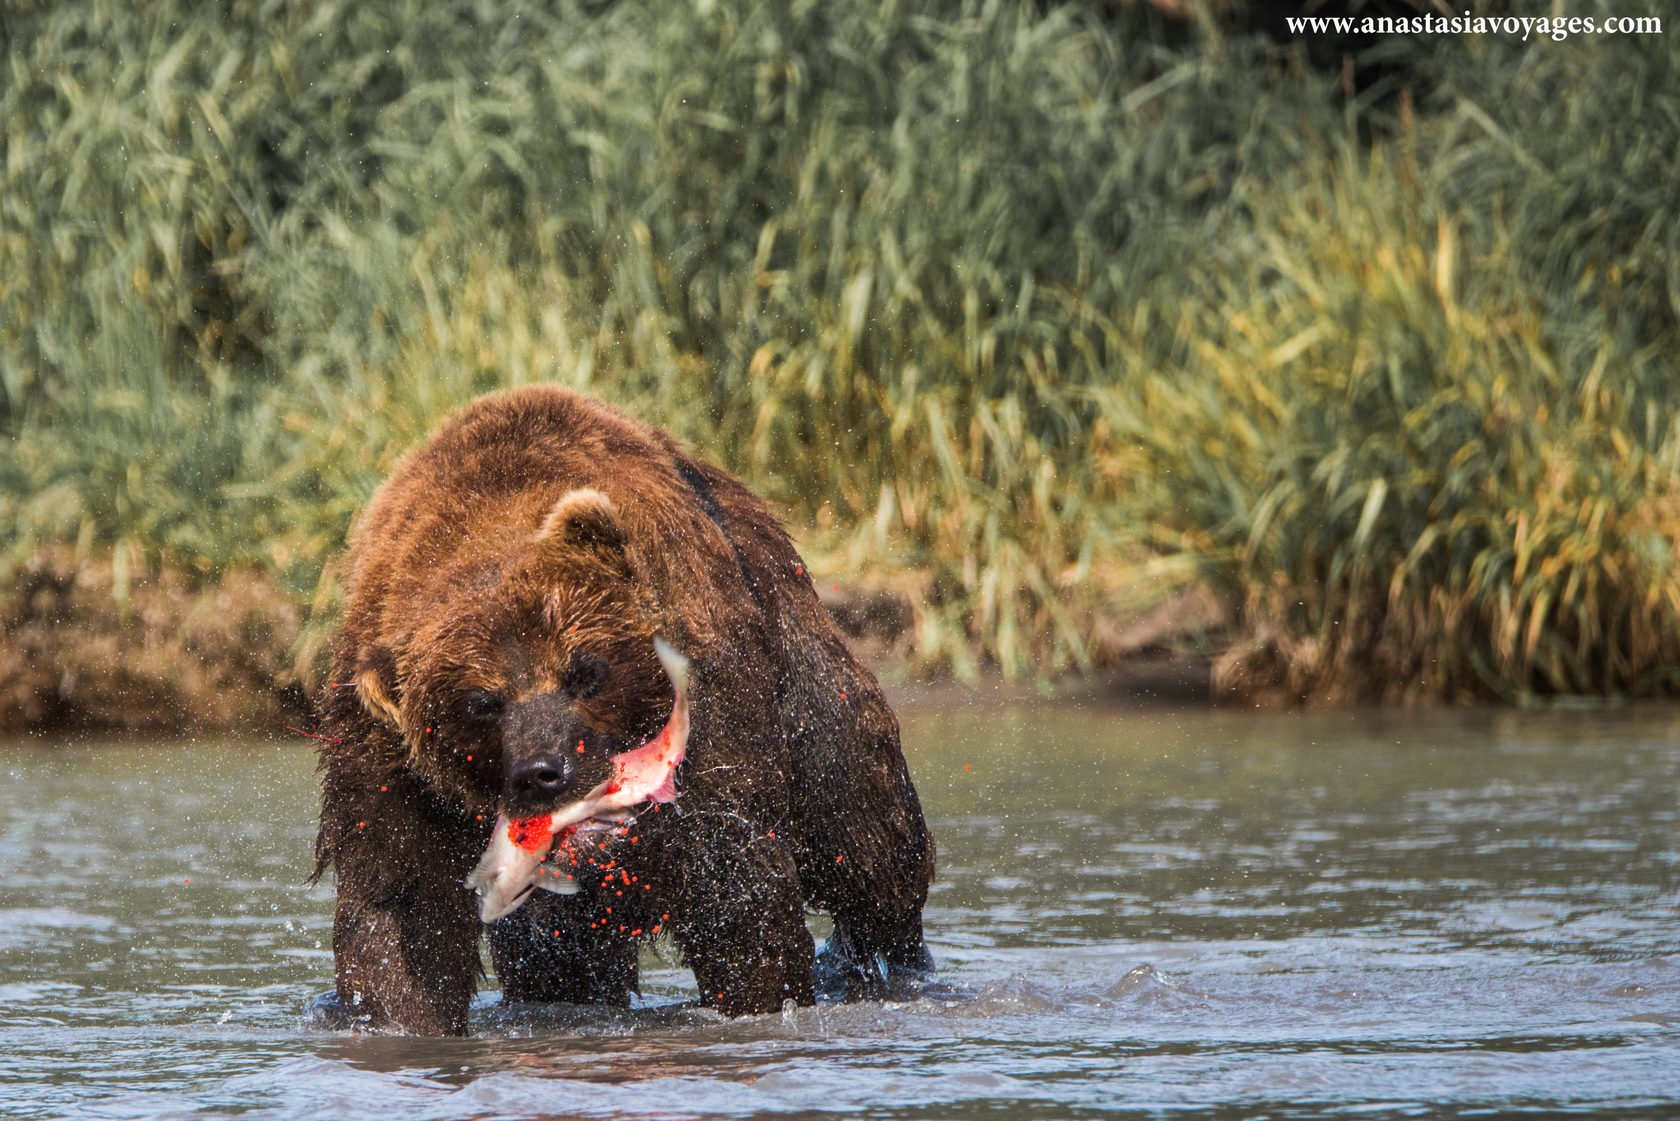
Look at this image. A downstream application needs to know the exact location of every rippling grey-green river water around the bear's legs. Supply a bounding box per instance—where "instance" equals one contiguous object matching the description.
[0,706,1680,1118]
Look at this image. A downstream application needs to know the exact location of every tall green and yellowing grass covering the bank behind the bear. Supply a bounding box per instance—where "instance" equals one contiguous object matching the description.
[0,0,1680,699]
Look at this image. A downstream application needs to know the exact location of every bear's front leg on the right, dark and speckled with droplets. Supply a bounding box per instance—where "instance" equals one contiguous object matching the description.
[672,813,816,1015]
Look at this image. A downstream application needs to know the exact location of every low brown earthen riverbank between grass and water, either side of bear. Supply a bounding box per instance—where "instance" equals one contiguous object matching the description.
[0,550,1225,736]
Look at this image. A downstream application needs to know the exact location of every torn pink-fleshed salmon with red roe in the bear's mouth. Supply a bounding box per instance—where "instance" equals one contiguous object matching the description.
[467,639,689,923]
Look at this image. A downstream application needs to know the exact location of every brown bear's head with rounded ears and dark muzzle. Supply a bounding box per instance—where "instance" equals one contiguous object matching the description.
[354,489,672,817]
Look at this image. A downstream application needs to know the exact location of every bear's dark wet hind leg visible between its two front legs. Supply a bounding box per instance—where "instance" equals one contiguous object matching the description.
[491,891,637,1007]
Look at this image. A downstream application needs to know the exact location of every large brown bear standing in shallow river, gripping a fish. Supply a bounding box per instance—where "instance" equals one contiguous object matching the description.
[316,387,934,1034]
